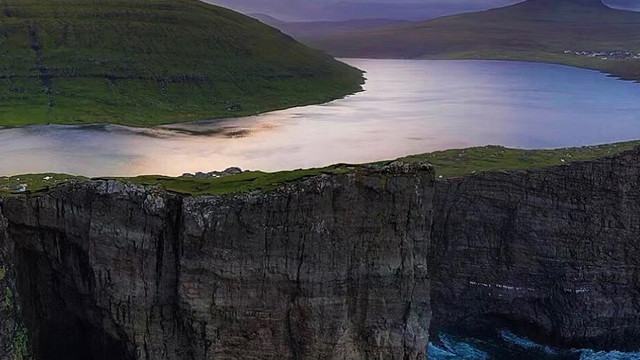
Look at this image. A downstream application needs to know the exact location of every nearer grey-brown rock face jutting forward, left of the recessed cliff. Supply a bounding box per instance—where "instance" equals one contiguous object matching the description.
[0,165,433,360]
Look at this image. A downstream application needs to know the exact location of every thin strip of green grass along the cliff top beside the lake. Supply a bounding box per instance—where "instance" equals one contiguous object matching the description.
[0,141,640,197]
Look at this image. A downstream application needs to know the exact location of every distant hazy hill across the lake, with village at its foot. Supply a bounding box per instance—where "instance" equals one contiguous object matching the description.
[305,0,640,80]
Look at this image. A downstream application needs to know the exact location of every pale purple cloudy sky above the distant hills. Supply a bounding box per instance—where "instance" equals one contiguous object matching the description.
[204,0,640,21]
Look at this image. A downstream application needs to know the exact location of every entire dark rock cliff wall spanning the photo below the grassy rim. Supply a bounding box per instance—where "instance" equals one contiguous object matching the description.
[0,149,640,360]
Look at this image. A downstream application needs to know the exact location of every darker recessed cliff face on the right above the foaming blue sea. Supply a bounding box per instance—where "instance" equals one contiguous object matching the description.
[429,151,640,349]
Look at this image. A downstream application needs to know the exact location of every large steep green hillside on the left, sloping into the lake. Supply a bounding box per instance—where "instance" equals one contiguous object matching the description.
[0,0,362,126]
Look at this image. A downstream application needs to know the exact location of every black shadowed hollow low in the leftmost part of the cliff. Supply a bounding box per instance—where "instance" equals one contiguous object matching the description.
[15,235,133,360]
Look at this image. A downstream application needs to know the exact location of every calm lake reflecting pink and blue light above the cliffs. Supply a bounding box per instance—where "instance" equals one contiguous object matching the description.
[0,59,640,176]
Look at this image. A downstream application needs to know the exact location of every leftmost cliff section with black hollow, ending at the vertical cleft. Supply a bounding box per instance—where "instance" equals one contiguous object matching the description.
[2,182,184,360]
